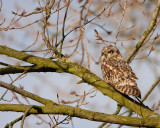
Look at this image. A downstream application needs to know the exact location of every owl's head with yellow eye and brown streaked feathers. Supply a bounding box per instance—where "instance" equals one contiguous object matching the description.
[100,45,122,62]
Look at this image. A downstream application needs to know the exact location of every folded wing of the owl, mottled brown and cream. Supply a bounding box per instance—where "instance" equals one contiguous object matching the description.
[105,59,141,97]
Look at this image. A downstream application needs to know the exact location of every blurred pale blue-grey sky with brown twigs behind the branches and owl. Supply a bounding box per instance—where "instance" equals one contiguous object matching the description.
[0,0,160,128]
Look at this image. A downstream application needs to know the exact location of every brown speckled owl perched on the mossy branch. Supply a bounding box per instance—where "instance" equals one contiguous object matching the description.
[99,45,141,98]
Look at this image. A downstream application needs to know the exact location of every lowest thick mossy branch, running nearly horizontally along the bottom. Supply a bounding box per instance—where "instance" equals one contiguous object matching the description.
[0,104,160,127]
